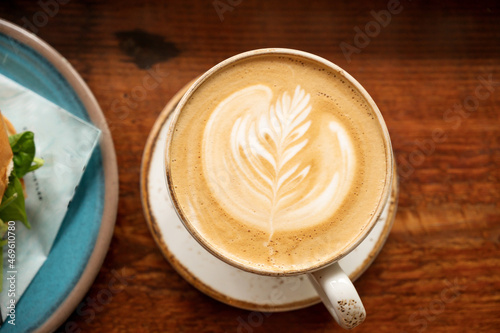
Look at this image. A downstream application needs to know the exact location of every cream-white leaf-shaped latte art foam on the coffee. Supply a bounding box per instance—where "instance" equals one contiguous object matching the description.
[202,85,356,237]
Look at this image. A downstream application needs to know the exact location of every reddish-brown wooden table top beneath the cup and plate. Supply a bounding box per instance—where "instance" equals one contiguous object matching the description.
[0,0,500,332]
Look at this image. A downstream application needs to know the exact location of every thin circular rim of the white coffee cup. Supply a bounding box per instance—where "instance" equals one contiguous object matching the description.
[163,48,394,276]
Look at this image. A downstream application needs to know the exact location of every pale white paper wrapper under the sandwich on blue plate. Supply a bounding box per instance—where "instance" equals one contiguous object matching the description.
[0,75,100,321]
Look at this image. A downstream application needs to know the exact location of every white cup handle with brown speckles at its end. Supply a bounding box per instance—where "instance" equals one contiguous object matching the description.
[308,263,366,329]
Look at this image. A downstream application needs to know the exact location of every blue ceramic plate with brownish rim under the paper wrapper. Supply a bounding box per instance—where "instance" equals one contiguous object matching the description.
[0,20,118,332]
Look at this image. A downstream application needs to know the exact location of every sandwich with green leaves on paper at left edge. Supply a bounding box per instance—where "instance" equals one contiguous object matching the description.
[0,112,43,231]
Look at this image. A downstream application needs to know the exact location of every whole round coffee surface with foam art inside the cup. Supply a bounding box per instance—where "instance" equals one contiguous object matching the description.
[167,54,390,274]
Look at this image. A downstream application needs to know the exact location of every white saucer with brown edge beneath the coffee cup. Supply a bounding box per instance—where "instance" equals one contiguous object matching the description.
[141,83,399,312]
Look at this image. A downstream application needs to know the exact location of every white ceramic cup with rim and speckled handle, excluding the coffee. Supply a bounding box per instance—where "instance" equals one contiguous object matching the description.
[165,48,394,329]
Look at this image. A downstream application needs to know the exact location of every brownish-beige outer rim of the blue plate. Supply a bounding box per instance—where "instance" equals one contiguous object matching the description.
[0,18,119,332]
